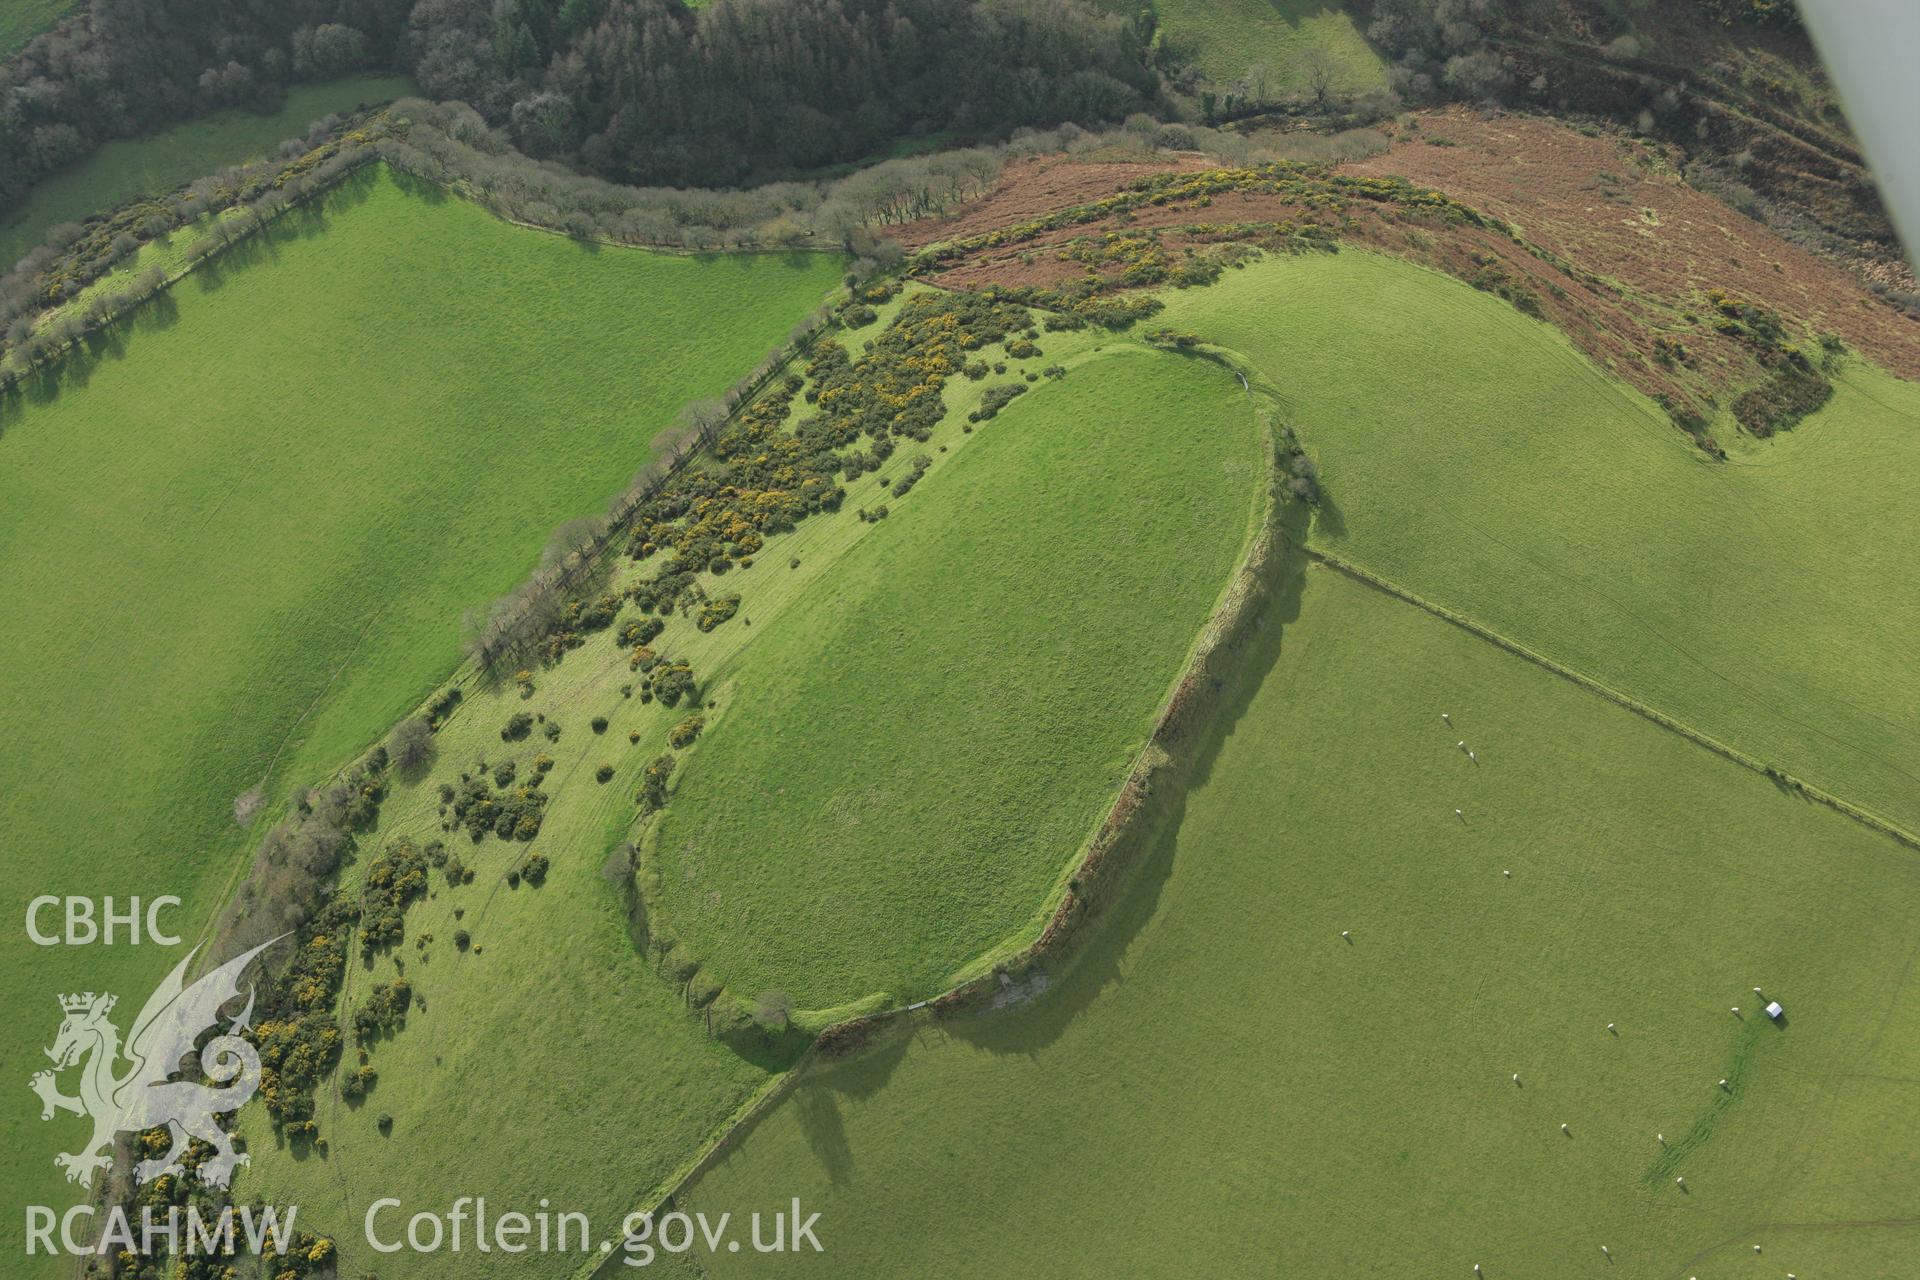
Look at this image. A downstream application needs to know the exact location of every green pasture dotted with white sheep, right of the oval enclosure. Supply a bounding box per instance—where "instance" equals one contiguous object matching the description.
[682,560,1920,1280]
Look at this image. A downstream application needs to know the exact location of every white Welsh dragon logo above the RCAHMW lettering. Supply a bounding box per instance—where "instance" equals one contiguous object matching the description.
[31,935,284,1186]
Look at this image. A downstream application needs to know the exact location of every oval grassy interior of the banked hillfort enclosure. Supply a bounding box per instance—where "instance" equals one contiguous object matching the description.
[659,347,1260,1007]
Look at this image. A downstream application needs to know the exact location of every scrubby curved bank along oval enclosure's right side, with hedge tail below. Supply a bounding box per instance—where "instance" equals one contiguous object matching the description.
[576,362,1282,1278]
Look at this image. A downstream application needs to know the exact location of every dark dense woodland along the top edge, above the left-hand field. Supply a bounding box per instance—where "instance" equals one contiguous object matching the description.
[0,0,1158,207]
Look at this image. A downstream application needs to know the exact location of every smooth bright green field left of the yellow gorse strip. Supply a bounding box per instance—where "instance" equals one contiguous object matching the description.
[0,175,839,1251]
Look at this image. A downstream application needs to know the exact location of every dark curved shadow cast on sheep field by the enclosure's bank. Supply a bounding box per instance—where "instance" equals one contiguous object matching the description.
[943,507,1308,1057]
